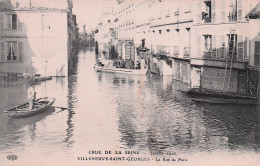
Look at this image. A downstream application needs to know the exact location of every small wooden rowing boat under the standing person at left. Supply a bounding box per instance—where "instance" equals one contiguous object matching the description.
[4,97,55,118]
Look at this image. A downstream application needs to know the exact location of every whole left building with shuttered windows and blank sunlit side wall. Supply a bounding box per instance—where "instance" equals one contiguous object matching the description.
[0,0,78,76]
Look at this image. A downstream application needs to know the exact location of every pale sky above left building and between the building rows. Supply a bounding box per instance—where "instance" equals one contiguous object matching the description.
[12,0,117,32]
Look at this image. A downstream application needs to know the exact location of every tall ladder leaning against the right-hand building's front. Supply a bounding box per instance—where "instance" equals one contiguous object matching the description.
[223,29,237,92]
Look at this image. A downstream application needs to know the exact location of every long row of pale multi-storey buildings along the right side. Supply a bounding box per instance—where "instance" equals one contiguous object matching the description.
[94,0,259,96]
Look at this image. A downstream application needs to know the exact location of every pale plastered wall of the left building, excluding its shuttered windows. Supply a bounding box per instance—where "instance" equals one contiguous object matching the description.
[0,11,68,76]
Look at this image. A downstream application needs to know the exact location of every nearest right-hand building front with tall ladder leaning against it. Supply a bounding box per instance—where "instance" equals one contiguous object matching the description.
[190,0,259,96]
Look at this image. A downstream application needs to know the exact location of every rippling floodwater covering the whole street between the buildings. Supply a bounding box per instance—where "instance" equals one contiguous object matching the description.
[0,50,260,165]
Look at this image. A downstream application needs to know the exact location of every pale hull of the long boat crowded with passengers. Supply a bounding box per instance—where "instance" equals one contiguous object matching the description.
[94,64,148,75]
